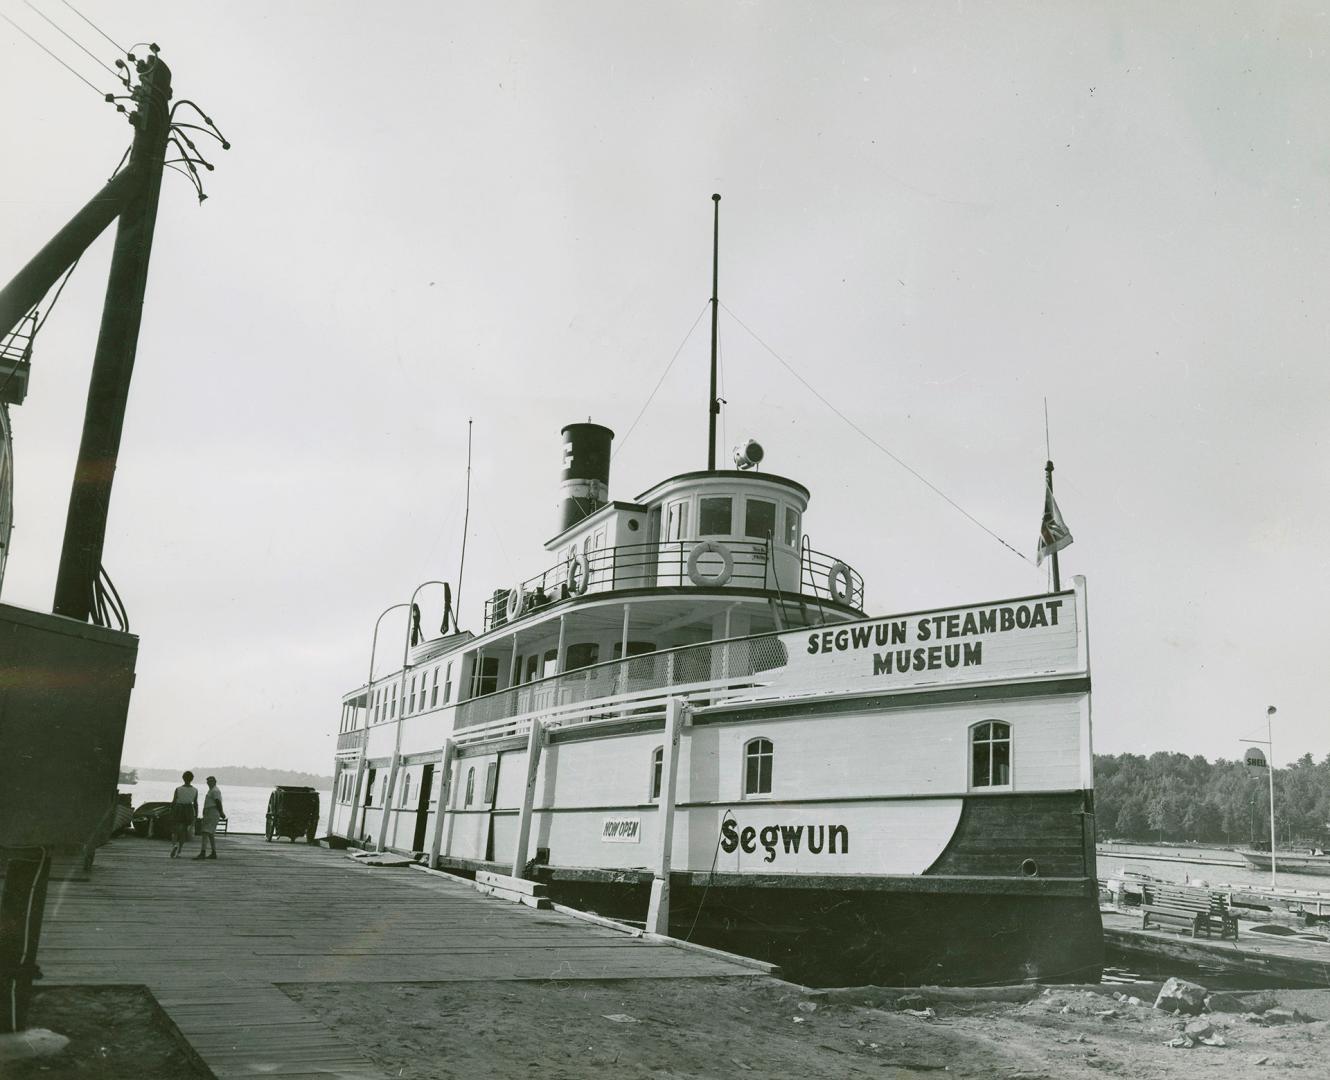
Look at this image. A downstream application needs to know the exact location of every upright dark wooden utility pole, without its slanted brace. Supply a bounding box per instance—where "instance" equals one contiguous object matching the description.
[52,55,172,622]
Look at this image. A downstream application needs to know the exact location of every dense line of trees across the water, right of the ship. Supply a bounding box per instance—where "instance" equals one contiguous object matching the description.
[1095,750,1330,847]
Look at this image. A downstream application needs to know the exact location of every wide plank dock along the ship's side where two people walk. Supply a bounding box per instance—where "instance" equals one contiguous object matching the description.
[37,837,755,1080]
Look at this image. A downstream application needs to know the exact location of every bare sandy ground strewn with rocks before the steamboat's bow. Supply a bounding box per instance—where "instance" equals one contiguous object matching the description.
[283,976,1330,1080]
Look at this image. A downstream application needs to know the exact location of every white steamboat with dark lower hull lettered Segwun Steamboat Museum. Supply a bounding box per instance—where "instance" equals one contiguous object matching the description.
[327,202,1103,986]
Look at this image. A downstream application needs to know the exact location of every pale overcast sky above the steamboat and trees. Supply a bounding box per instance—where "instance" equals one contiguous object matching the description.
[0,0,1330,771]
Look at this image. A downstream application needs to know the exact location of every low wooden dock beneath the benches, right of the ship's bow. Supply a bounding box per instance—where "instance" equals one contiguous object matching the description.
[1103,911,1330,988]
